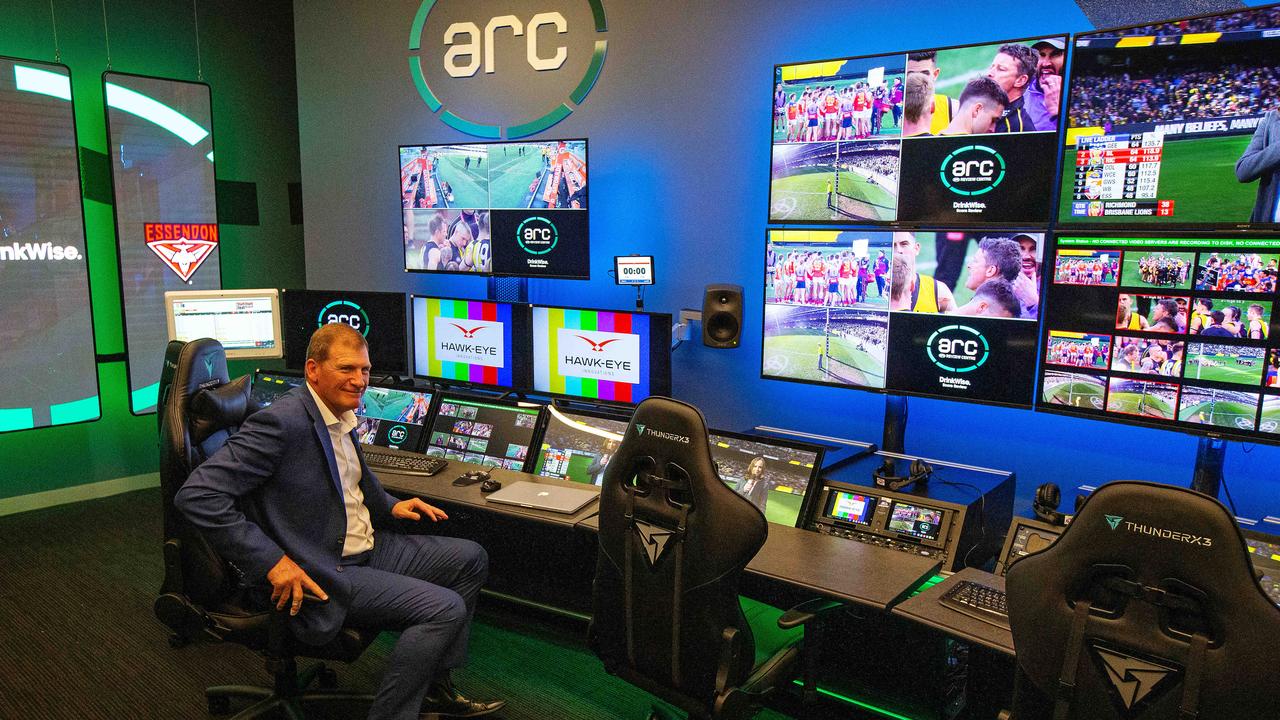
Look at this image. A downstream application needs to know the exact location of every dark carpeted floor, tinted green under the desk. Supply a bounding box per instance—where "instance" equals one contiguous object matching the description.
[0,489,870,720]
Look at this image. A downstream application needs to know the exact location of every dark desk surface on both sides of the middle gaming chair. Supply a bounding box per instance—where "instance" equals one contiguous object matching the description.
[378,461,940,610]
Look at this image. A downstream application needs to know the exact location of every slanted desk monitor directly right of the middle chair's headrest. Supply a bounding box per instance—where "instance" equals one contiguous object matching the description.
[708,430,823,527]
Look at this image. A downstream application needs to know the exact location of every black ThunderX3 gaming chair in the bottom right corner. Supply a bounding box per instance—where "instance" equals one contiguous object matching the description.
[1005,482,1280,720]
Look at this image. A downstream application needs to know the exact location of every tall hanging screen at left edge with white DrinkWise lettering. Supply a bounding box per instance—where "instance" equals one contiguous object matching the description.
[0,58,99,432]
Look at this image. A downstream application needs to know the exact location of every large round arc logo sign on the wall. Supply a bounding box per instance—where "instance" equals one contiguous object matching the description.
[408,0,608,140]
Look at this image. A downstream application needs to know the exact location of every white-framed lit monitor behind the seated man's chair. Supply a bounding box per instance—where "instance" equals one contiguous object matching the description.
[164,288,284,360]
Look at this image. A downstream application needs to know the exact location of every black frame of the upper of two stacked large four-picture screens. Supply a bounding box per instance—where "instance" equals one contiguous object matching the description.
[764,32,1075,231]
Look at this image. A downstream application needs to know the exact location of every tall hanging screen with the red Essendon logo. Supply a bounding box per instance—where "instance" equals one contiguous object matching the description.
[102,73,223,414]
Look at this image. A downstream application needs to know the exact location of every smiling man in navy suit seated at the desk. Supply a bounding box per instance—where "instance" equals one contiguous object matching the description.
[175,324,504,720]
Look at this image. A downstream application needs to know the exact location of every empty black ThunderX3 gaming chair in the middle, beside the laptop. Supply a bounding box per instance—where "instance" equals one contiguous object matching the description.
[589,397,836,719]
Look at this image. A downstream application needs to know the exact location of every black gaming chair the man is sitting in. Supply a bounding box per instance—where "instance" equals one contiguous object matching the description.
[155,338,376,719]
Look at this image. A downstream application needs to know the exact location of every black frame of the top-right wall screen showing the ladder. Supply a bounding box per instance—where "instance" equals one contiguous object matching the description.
[1052,3,1280,229]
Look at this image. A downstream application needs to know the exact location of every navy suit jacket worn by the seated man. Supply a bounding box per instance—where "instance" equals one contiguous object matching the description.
[174,384,396,644]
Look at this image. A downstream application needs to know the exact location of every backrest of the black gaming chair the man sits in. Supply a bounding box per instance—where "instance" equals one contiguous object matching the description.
[160,338,257,607]
